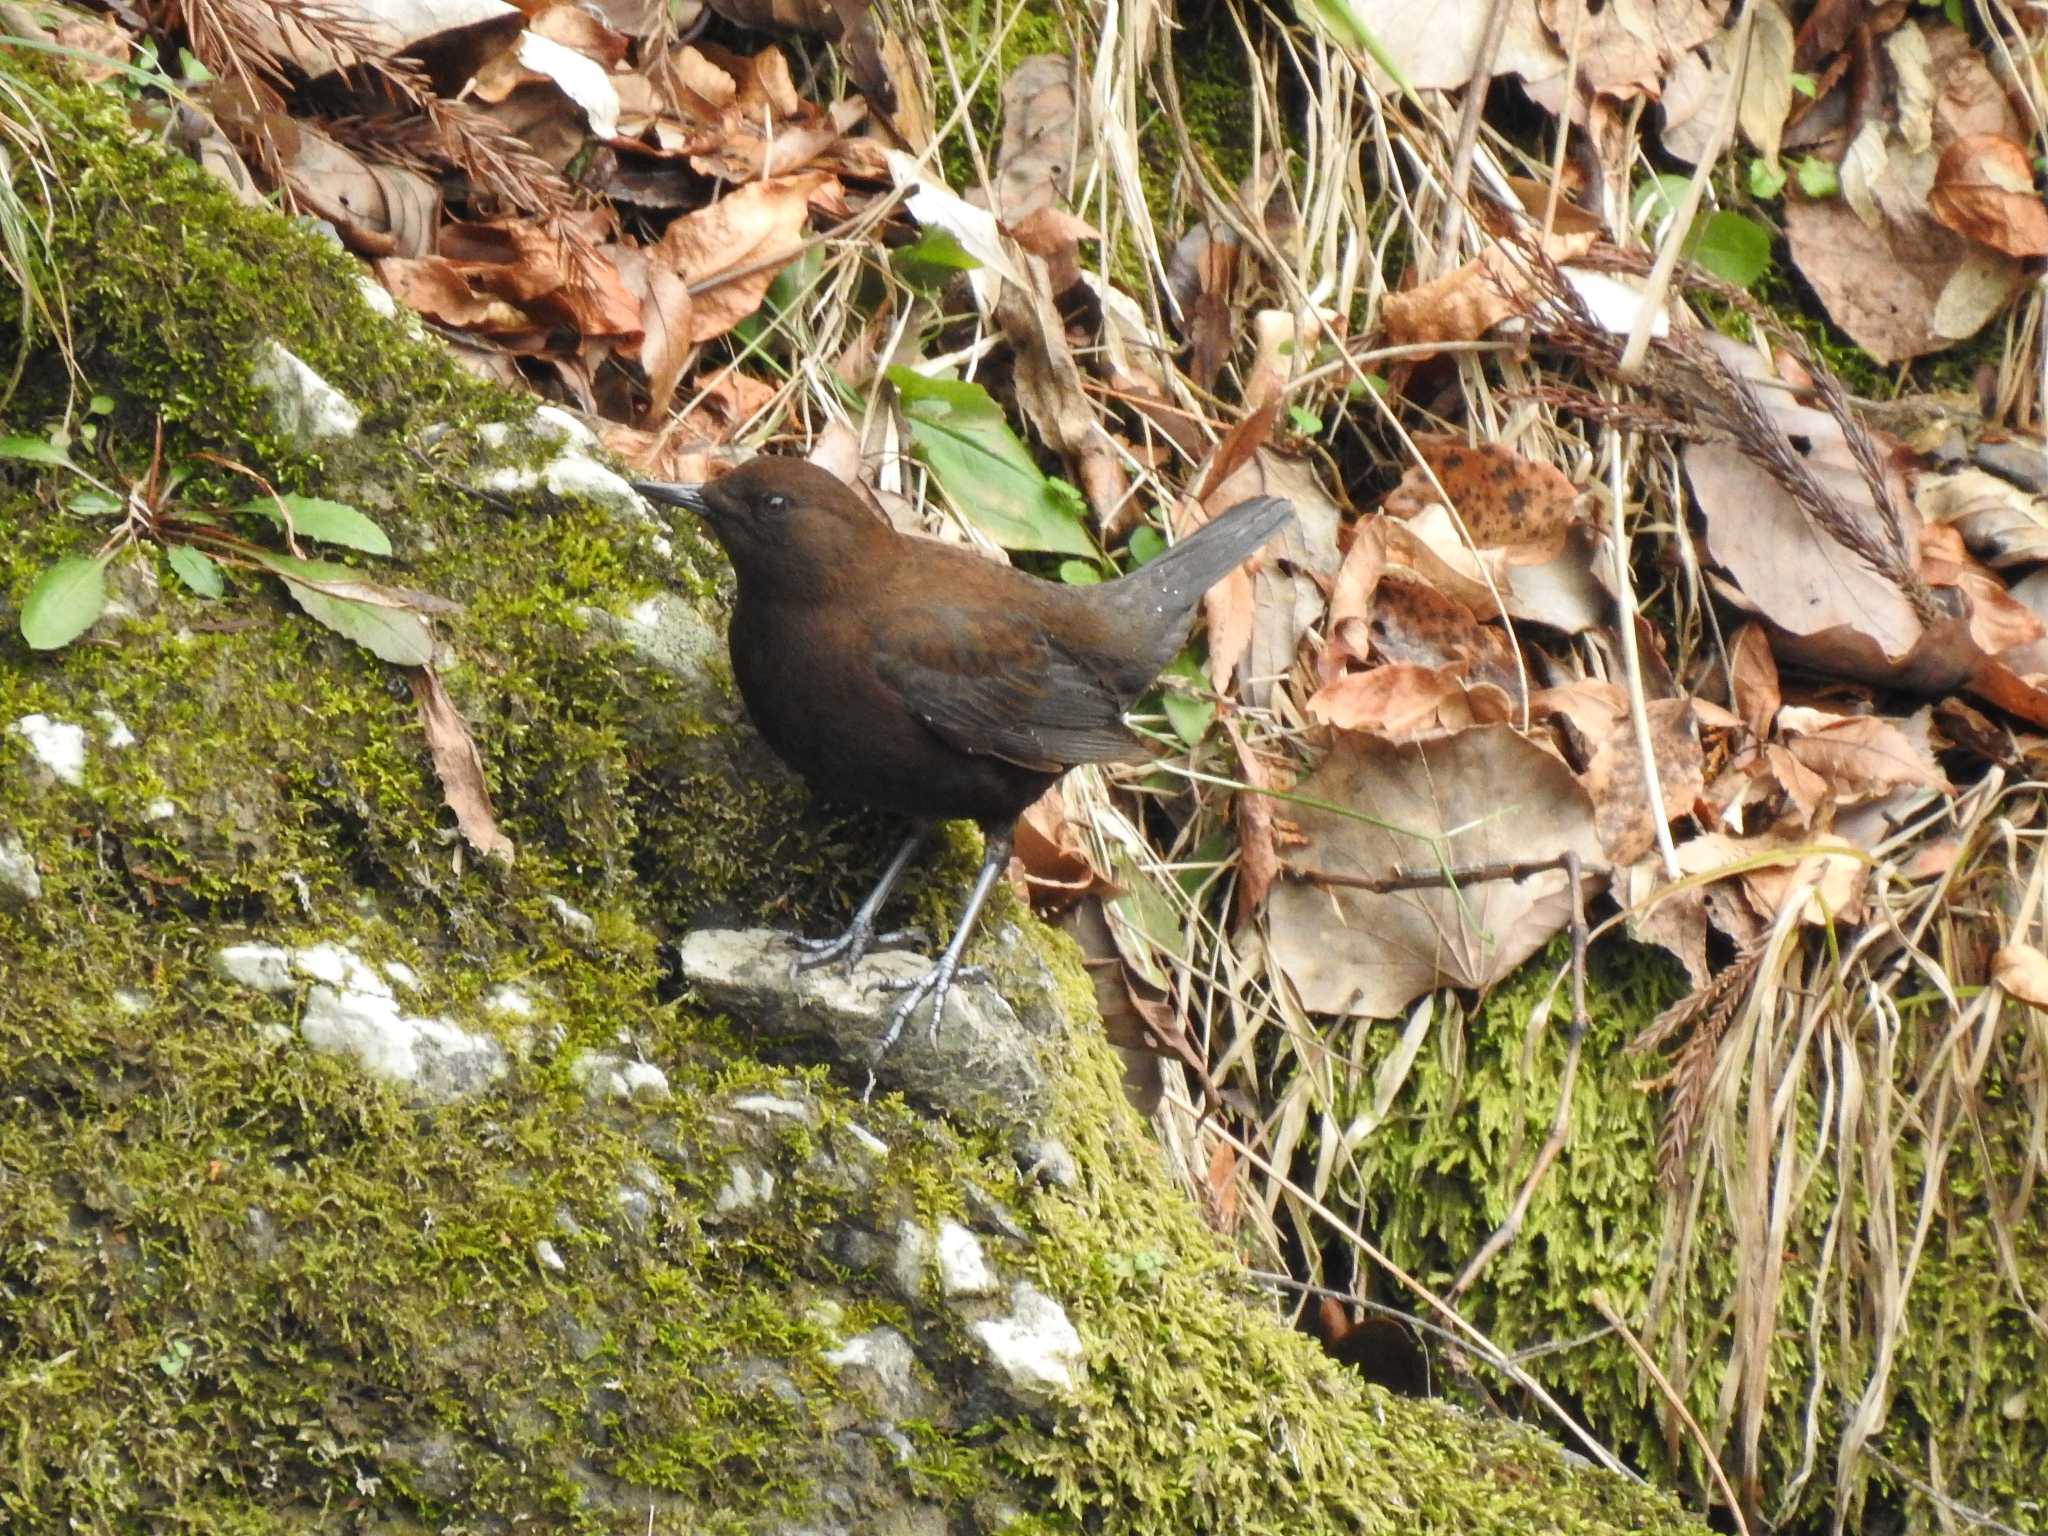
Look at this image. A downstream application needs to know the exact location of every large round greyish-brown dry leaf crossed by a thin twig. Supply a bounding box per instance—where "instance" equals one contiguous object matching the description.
[1268,725,1602,1018]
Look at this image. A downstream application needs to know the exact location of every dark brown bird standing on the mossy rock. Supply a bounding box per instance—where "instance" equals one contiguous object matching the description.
[633,455,1292,1061]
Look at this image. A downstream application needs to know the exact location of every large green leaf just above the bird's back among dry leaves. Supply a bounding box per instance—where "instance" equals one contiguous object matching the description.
[889,369,1102,559]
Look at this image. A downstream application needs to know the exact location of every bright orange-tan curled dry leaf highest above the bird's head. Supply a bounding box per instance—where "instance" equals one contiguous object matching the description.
[649,170,840,342]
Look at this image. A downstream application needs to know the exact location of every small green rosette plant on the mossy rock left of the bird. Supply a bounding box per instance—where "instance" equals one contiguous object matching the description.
[0,423,449,666]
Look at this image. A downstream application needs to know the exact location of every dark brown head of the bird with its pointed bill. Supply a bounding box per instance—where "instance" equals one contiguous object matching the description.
[633,457,887,590]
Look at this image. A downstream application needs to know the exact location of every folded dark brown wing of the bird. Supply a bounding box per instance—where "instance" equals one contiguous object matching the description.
[874,604,1145,772]
